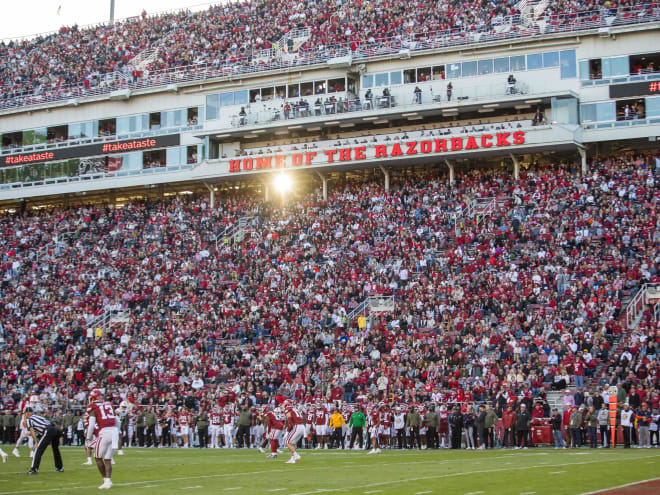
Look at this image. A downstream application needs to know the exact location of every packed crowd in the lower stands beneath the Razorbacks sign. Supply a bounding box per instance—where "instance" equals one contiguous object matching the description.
[0,151,660,426]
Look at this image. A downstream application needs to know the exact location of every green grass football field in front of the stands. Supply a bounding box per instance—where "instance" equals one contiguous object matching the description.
[0,447,660,495]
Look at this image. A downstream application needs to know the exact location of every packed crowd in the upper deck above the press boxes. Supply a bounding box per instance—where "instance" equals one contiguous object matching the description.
[0,0,658,106]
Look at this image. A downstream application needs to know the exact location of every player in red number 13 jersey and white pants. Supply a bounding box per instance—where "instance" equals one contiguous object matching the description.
[87,388,119,490]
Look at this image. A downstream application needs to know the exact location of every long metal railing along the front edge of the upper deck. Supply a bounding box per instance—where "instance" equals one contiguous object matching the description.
[0,5,660,109]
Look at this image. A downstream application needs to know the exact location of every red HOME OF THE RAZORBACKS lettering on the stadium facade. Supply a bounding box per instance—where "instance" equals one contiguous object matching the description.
[229,131,525,172]
